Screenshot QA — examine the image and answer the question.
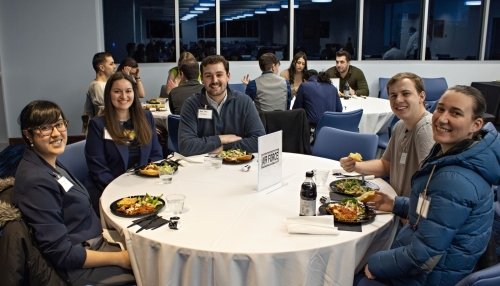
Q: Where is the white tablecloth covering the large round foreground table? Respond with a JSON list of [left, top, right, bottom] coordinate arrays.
[[100, 153, 396, 286]]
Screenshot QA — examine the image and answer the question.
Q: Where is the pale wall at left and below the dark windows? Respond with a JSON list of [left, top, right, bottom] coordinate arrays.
[[0, 0, 500, 144]]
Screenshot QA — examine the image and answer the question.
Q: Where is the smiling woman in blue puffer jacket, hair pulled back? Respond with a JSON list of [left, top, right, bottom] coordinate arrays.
[[358, 86, 500, 286]]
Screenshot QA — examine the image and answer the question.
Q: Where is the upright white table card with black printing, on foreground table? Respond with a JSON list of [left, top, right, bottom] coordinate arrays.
[[257, 130, 283, 191]]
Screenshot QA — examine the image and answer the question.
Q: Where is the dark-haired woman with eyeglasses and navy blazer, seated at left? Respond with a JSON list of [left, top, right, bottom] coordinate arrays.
[[13, 100, 135, 285]]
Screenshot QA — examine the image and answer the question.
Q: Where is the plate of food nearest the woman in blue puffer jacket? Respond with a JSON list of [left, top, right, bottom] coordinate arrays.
[[326, 198, 375, 223]]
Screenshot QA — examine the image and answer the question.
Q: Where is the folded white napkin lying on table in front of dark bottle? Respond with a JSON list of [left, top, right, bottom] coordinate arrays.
[[286, 216, 339, 234]]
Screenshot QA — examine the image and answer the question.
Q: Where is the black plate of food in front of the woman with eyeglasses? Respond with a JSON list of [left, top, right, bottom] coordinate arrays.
[[110, 194, 165, 217]]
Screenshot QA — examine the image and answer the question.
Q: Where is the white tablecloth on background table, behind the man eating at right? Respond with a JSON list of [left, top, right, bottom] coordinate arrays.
[[341, 97, 394, 134]]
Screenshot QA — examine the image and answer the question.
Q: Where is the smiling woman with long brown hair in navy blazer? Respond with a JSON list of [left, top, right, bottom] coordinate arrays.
[[85, 72, 163, 196]]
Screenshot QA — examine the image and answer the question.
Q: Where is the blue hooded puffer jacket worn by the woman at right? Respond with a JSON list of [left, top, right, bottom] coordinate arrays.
[[368, 125, 500, 286]]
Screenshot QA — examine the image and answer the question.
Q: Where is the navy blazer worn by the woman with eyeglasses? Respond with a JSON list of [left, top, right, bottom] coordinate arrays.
[[12, 149, 102, 270]]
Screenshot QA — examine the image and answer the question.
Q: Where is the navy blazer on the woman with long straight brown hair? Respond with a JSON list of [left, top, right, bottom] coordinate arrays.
[[85, 110, 163, 192]]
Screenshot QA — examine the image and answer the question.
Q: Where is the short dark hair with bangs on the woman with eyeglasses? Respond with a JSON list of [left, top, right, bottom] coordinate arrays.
[[19, 100, 66, 146]]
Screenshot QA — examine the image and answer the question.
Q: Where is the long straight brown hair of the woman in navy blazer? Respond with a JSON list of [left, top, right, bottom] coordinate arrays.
[[104, 72, 153, 145]]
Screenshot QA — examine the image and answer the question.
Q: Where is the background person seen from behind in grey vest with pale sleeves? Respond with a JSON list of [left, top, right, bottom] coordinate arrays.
[[241, 53, 292, 112]]
